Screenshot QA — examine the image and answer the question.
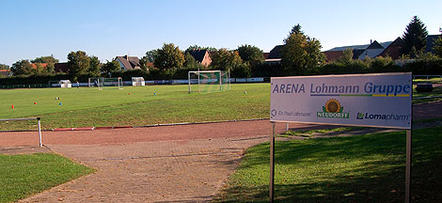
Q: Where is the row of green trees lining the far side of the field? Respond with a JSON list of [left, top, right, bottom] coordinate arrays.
[[0, 16, 442, 81]]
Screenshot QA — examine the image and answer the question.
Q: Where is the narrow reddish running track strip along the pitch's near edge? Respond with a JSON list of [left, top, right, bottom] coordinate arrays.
[[0, 120, 314, 146]]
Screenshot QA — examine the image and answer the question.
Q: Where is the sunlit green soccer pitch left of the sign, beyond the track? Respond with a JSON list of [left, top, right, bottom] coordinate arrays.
[[0, 83, 270, 130]]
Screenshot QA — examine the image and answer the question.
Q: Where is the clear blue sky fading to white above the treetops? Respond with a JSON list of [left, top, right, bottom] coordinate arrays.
[[0, 0, 442, 65]]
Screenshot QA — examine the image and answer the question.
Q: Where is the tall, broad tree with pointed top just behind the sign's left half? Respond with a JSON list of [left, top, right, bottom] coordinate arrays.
[[281, 24, 325, 74]]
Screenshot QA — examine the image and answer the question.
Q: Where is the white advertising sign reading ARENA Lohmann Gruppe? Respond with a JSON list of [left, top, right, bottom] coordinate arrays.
[[270, 73, 413, 129]]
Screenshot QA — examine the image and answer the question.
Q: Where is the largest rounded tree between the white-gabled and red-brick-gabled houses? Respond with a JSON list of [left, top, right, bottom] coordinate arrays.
[[154, 43, 184, 70]]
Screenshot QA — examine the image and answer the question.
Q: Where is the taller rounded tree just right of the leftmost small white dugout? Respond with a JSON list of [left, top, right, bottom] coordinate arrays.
[[68, 51, 91, 82]]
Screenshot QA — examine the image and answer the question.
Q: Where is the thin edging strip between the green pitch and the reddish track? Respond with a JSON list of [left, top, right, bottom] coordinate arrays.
[[0, 118, 269, 133]]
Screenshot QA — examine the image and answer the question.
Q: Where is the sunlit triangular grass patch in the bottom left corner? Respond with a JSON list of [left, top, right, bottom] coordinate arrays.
[[0, 153, 94, 202]]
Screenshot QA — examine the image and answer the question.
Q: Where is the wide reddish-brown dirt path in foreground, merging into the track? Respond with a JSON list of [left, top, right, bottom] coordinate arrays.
[[0, 121, 308, 202]]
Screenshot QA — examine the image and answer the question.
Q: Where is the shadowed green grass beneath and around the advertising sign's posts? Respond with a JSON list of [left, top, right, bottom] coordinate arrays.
[[214, 127, 442, 202]]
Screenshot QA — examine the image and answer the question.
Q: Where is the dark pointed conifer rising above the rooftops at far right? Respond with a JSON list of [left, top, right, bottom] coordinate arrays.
[[402, 16, 428, 58]]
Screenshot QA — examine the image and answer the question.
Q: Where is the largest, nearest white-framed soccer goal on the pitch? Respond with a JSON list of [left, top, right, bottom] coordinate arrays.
[[188, 70, 230, 93]]
